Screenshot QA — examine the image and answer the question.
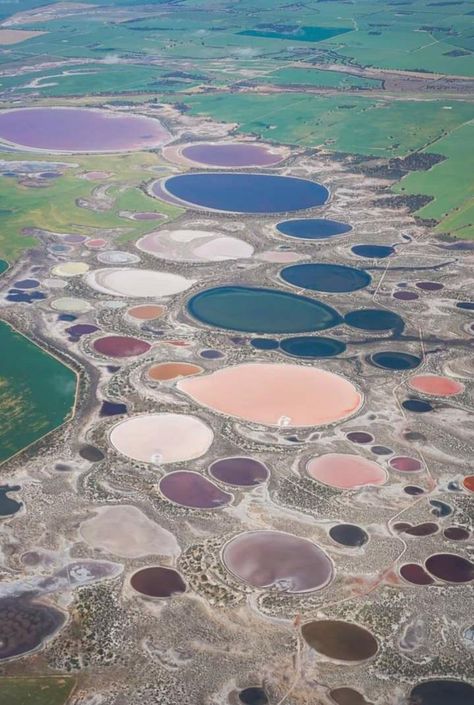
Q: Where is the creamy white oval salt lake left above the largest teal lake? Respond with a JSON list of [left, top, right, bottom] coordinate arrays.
[[86, 267, 195, 298]]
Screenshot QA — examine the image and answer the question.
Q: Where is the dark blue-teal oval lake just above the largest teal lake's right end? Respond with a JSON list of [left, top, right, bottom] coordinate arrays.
[[280, 263, 371, 294]]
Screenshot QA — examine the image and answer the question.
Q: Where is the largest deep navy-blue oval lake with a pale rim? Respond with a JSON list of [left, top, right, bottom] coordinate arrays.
[[161, 172, 329, 213]]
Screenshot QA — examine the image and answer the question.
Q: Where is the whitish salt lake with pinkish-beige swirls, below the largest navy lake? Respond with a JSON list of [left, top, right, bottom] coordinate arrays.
[[136, 229, 253, 262]]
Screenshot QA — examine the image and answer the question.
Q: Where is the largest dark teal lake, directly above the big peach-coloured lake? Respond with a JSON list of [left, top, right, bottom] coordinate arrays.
[[188, 286, 343, 334]]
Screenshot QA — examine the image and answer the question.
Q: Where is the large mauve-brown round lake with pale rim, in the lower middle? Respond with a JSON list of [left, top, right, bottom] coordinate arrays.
[[222, 531, 334, 594]]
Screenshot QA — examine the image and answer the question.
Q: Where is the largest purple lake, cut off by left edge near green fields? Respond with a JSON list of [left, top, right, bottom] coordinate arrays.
[[0, 108, 170, 152]]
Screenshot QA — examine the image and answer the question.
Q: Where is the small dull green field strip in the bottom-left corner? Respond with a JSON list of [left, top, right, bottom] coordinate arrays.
[[0, 676, 75, 705]]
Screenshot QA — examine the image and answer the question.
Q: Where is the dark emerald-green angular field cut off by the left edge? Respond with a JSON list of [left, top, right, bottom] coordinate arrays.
[[0, 321, 76, 463]]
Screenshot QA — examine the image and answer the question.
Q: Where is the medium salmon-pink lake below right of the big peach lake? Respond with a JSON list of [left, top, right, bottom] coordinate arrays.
[[306, 453, 387, 489]]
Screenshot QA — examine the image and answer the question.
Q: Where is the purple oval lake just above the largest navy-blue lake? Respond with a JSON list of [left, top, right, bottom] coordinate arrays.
[[180, 142, 283, 167]]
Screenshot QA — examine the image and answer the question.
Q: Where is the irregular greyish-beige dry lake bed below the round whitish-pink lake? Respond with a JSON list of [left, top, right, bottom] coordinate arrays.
[[80, 505, 181, 558]]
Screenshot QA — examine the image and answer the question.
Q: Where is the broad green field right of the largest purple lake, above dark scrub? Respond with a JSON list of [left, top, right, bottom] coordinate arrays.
[[178, 93, 474, 157]]
